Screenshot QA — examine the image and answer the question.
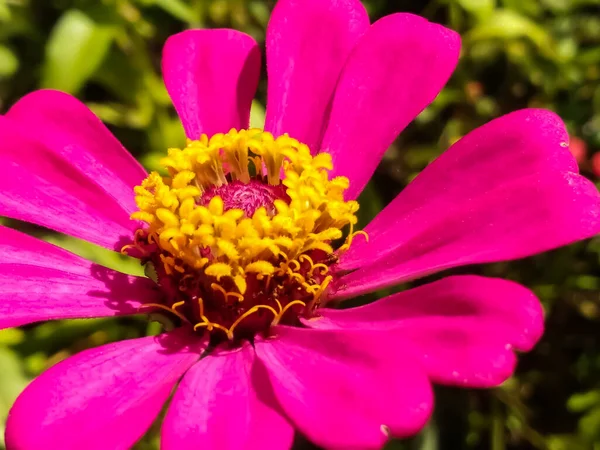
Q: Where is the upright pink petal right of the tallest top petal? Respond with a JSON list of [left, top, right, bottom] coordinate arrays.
[[322, 14, 460, 199]]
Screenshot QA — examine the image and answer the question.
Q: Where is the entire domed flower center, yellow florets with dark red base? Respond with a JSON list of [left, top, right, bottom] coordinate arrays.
[[124, 129, 364, 341]]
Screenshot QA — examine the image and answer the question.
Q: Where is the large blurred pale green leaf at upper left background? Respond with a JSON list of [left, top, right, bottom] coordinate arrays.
[[42, 9, 115, 94]]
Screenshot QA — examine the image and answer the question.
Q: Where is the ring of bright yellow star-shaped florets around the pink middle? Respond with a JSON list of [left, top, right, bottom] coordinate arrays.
[[132, 129, 358, 295]]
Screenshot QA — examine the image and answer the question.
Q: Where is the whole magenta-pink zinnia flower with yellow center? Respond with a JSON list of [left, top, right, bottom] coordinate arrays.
[[0, 0, 600, 450]]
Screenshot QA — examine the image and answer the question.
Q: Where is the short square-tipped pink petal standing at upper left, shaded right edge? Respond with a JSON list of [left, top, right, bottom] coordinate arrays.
[[162, 29, 260, 139]]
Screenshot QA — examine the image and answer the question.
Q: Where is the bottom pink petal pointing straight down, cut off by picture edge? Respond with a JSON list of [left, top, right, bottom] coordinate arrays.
[[161, 344, 294, 450]]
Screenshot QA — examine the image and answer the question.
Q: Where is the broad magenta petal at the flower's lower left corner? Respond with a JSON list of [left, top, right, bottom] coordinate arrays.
[[6, 334, 199, 450]]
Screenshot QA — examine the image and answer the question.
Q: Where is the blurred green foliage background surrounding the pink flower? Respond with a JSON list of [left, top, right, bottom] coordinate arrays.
[[0, 0, 600, 450]]
